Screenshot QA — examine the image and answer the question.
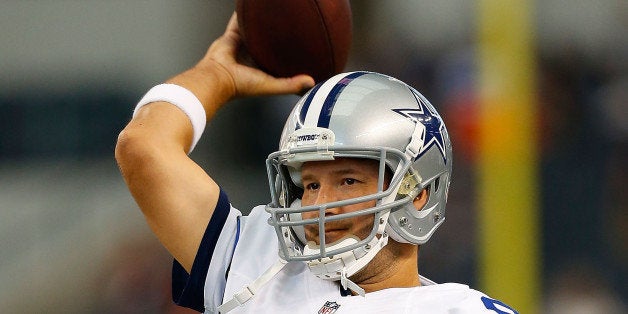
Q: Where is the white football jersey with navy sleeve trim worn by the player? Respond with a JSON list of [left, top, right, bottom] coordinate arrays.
[[173, 192, 516, 314]]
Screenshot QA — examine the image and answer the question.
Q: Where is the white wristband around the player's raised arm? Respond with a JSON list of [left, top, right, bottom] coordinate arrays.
[[133, 84, 207, 154]]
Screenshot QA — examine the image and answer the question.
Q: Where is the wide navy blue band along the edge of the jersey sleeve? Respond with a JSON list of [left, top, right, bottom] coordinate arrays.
[[172, 189, 231, 312]]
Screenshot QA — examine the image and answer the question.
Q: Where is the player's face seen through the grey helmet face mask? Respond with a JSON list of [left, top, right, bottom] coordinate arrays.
[[301, 158, 386, 245]]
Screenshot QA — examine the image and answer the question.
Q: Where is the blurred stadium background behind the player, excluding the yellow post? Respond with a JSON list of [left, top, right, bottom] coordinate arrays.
[[0, 0, 628, 314]]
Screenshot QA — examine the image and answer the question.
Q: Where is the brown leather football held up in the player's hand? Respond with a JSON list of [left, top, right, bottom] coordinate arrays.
[[236, 0, 352, 82]]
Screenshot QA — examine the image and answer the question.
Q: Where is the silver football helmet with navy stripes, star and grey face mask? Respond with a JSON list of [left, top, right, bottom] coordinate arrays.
[[266, 72, 452, 290]]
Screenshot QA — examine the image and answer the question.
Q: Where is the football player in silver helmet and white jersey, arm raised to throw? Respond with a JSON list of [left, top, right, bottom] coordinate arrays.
[[116, 13, 516, 314]]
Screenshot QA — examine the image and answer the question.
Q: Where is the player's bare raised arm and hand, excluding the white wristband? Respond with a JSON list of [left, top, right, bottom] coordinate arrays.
[[115, 14, 314, 272]]
